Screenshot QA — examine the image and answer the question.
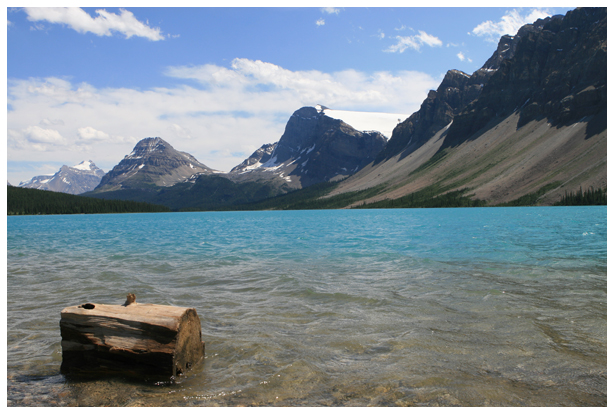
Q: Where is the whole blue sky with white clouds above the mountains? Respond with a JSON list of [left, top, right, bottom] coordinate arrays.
[[6, 1, 584, 185]]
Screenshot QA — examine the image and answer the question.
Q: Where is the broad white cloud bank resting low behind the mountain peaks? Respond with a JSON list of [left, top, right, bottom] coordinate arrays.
[[7, 59, 441, 182]]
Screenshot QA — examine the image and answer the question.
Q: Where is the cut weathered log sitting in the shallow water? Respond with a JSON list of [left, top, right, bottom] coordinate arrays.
[[60, 294, 205, 377]]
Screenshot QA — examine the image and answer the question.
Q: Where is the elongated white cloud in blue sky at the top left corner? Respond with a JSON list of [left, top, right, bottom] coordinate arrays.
[[24, 7, 164, 40]]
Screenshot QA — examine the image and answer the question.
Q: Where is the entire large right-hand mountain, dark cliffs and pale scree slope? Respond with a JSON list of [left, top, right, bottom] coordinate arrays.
[[330, 8, 607, 205]]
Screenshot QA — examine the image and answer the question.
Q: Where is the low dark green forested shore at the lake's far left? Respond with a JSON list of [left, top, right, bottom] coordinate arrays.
[[7, 186, 170, 215]]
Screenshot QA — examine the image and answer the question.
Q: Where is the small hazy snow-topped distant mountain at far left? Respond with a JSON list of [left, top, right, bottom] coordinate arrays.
[[19, 161, 104, 194]]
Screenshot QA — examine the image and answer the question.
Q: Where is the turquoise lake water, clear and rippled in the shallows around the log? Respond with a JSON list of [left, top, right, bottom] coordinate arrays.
[[7, 207, 607, 406]]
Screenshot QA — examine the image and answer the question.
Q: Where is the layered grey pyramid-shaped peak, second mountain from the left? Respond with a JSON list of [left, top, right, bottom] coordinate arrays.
[[96, 138, 213, 191]]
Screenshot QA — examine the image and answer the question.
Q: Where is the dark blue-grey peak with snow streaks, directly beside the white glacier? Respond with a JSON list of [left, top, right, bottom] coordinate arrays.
[[230, 107, 386, 187]]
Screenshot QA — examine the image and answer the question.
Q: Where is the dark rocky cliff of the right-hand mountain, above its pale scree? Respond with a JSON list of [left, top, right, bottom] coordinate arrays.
[[376, 8, 607, 163]]
